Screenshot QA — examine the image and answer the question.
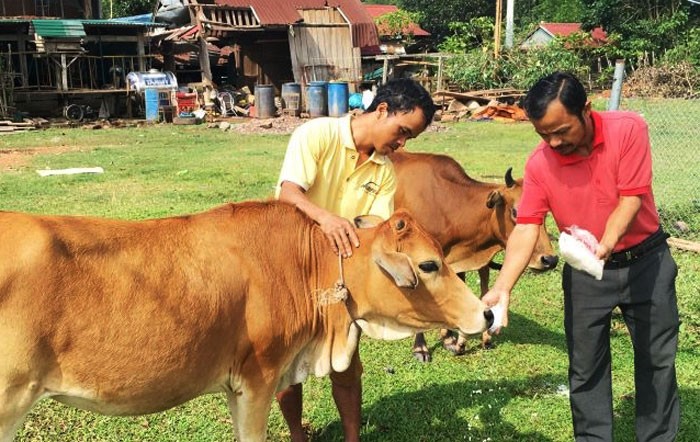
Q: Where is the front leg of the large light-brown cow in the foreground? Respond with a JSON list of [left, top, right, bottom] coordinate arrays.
[[227, 380, 275, 442]]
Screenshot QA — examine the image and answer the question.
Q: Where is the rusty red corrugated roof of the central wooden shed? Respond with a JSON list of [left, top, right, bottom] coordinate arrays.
[[215, 0, 379, 48]]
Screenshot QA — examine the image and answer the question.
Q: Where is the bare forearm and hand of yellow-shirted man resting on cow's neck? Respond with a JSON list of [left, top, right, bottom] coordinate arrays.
[[279, 181, 360, 258]]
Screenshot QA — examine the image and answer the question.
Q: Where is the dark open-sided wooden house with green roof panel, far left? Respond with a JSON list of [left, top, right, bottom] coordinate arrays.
[[0, 0, 162, 116]]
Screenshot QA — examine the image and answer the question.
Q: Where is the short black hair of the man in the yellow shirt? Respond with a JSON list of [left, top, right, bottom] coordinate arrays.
[[367, 78, 435, 127]]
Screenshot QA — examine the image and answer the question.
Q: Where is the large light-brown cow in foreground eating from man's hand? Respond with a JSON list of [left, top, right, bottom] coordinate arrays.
[[0, 202, 493, 442]]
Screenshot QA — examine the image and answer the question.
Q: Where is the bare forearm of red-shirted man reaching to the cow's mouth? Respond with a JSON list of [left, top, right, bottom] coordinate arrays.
[[481, 224, 540, 333]]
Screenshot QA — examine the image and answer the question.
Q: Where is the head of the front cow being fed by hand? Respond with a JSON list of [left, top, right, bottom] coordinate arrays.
[[347, 210, 493, 339]]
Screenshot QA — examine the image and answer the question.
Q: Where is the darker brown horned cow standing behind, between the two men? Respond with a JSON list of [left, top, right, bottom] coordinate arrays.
[[391, 151, 558, 362]]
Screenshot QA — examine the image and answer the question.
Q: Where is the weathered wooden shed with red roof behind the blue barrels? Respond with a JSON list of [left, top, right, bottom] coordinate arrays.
[[155, 0, 379, 89]]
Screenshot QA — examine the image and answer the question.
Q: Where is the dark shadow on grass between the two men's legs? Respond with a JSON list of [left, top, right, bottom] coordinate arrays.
[[311, 375, 566, 442]]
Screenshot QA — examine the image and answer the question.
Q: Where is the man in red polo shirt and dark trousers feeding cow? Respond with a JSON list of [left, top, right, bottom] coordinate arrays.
[[482, 72, 680, 441]]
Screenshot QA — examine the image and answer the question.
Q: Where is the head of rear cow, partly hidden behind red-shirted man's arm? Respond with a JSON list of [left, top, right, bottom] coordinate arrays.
[[486, 167, 559, 271]]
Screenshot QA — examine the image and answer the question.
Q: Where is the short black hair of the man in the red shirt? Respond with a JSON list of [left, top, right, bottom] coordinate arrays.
[[523, 72, 588, 120]]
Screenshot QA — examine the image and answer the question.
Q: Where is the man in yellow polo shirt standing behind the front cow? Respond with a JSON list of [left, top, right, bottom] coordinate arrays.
[[277, 79, 435, 442]]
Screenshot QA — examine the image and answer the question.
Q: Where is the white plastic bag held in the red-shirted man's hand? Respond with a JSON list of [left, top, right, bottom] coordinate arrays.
[[559, 226, 605, 281]]
